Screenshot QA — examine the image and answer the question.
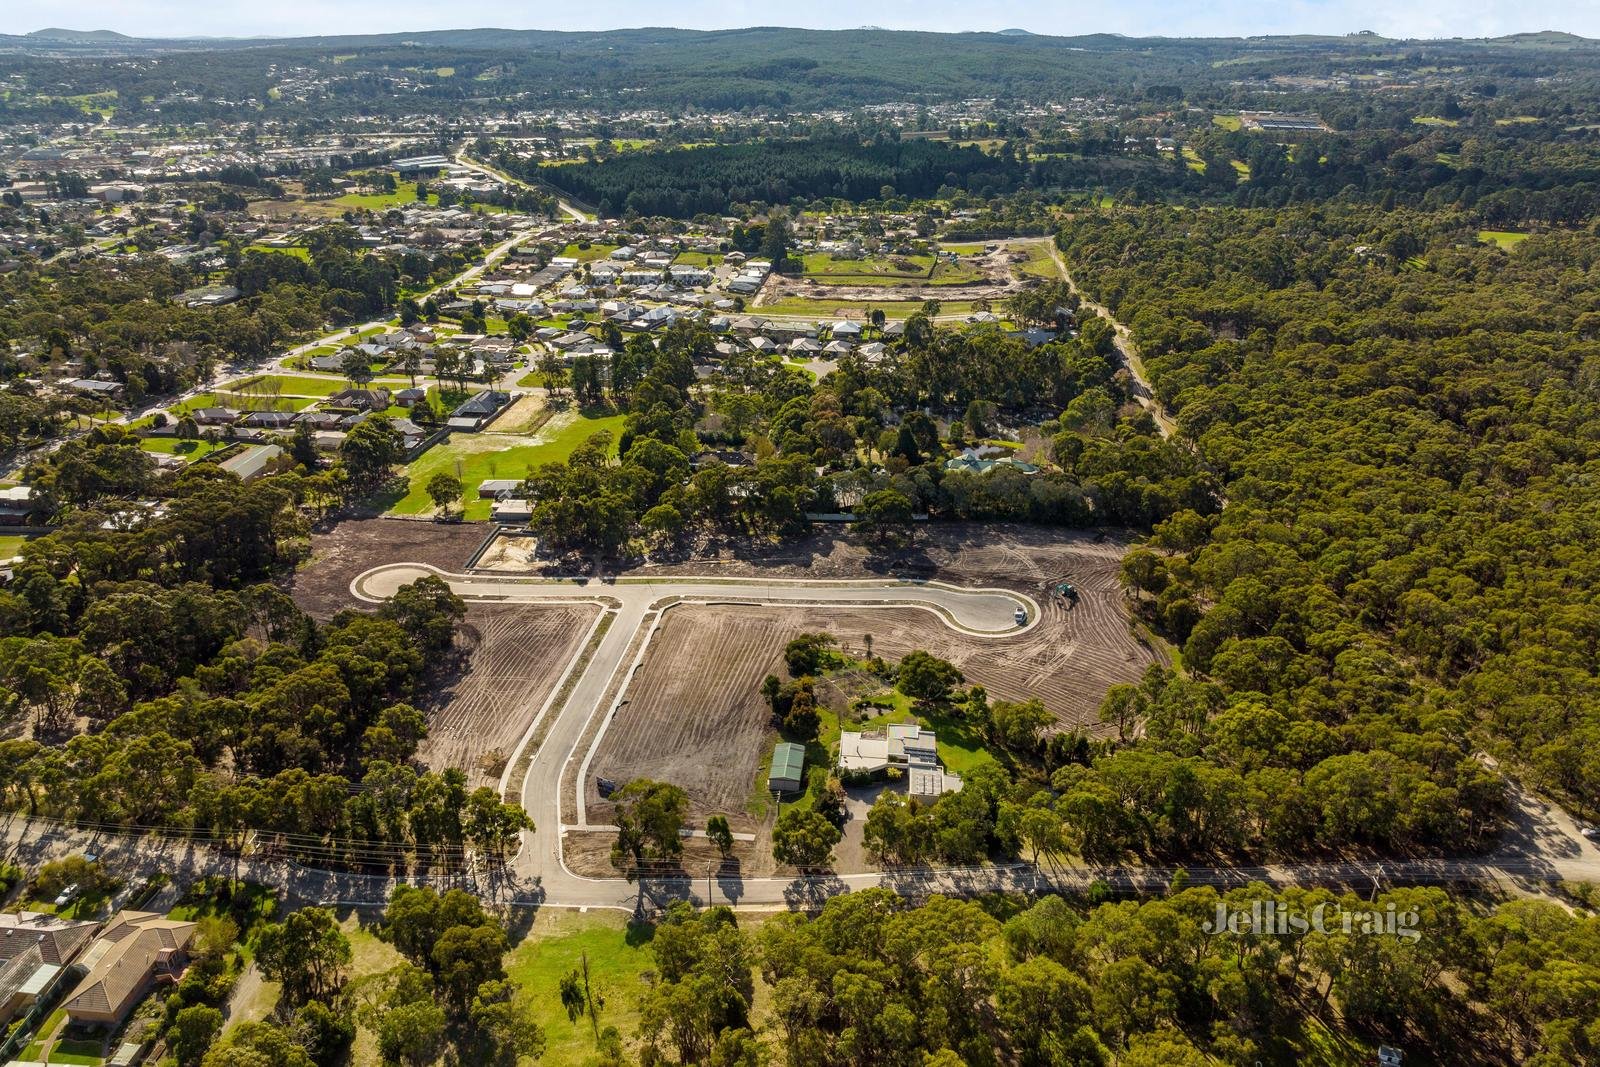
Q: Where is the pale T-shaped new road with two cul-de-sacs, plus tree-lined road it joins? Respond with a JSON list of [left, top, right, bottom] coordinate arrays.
[[344, 563, 1600, 910]]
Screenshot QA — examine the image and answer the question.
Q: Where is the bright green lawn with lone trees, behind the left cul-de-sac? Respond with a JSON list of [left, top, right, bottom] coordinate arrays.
[[389, 414, 626, 518]]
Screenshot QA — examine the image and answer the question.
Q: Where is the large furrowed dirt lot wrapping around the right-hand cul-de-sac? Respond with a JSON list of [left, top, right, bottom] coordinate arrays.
[[586, 528, 1162, 830]]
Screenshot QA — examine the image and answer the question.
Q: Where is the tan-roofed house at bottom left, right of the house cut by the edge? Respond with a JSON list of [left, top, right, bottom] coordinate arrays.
[[62, 912, 197, 1025]]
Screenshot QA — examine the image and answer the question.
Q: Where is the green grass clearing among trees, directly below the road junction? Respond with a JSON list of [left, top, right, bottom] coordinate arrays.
[[506, 910, 656, 1067]]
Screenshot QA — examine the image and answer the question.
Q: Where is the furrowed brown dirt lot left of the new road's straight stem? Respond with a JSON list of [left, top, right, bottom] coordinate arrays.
[[418, 605, 600, 787]]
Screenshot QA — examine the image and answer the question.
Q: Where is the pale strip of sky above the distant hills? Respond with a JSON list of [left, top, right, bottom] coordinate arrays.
[[12, 0, 1600, 37]]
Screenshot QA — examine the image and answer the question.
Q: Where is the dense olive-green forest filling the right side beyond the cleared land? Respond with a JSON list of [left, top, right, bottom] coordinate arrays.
[[1059, 205, 1600, 825]]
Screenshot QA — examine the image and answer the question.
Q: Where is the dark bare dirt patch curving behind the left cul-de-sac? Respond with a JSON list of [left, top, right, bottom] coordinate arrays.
[[288, 518, 488, 619]]
